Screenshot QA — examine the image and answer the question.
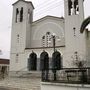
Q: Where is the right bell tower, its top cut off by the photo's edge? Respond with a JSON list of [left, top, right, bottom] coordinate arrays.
[[64, 0, 86, 67]]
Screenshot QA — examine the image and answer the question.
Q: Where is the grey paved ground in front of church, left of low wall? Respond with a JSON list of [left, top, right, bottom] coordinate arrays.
[[0, 77, 40, 90]]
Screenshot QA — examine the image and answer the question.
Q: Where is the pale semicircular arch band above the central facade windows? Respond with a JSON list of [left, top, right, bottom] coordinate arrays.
[[32, 22, 64, 39]]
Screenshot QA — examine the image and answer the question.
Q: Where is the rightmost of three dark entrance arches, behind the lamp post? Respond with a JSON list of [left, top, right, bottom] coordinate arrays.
[[52, 51, 62, 70]]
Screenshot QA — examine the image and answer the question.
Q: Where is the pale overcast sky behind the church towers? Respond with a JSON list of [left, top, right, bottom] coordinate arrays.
[[0, 0, 90, 58]]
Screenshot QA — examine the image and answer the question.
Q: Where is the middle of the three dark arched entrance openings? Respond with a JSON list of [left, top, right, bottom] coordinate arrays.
[[40, 51, 49, 70]]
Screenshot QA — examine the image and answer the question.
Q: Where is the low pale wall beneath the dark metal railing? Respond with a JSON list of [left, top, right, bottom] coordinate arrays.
[[41, 82, 90, 90]]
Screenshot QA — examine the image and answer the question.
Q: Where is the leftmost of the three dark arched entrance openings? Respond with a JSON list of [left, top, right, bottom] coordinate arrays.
[[28, 52, 37, 71]]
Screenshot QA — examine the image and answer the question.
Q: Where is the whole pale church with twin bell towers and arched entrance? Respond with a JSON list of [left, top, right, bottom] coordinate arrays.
[[10, 0, 90, 71]]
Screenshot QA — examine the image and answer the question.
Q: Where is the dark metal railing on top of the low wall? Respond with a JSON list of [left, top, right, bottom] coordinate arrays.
[[42, 67, 90, 84]]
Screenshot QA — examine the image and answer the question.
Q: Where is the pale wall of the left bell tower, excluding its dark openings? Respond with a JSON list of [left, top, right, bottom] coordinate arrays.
[[10, 0, 33, 71]]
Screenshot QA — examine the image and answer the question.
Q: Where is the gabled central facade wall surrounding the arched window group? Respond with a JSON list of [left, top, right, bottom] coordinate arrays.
[[31, 16, 65, 48]]
